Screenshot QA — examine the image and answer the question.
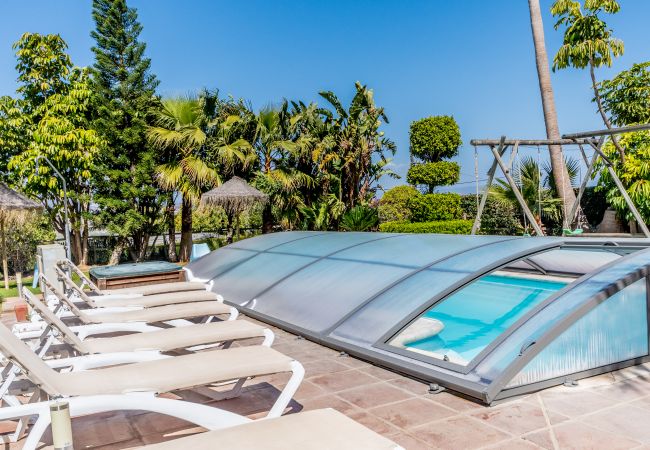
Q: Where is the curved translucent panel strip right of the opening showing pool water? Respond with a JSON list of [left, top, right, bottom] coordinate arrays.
[[475, 249, 650, 382]]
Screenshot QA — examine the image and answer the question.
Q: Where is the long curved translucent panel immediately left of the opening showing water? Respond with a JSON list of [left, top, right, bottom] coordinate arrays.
[[331, 236, 554, 346]]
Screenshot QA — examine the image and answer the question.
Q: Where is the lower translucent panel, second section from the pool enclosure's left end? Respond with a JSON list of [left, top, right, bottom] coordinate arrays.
[[212, 253, 315, 305]]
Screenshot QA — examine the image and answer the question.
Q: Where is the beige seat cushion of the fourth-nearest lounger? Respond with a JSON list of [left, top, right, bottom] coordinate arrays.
[[78, 301, 230, 323]]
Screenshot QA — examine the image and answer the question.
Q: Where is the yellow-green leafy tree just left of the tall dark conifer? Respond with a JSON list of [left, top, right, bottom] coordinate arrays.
[[2, 33, 103, 264]]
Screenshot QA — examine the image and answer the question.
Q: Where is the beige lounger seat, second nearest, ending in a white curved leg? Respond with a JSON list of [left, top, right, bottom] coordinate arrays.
[[51, 345, 293, 396]]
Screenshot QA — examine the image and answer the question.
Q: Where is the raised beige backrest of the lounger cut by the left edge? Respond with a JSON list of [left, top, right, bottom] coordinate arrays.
[[0, 322, 60, 396]]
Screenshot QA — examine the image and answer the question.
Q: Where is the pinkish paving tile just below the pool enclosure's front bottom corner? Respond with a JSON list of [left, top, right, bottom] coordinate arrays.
[[471, 402, 547, 435]]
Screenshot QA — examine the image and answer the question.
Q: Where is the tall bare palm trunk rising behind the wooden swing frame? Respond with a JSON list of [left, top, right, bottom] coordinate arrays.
[[528, 0, 576, 228]]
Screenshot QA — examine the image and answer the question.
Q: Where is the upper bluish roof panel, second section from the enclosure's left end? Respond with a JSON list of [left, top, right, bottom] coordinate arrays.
[[269, 233, 392, 257]]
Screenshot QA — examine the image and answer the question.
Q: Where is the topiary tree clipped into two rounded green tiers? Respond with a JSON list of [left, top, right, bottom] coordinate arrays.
[[407, 116, 463, 193]]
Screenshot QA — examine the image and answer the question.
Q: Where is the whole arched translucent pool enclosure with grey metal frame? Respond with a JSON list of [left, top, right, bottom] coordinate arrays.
[[187, 232, 650, 403]]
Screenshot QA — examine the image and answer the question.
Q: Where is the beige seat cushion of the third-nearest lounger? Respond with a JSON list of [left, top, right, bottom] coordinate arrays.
[[83, 320, 265, 353]]
